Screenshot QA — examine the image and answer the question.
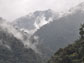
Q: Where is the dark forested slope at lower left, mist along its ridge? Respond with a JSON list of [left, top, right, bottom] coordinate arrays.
[[0, 19, 41, 63]]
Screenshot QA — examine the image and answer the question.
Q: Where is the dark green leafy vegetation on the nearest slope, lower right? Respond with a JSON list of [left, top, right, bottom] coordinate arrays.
[[48, 24, 84, 63]]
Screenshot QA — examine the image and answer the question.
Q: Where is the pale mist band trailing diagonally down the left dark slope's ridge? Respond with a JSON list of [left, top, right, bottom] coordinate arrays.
[[0, 20, 40, 53]]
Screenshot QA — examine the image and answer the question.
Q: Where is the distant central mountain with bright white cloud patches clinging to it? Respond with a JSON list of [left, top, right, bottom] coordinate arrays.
[[13, 9, 58, 33]]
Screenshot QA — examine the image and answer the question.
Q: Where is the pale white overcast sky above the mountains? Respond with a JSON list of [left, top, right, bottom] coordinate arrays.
[[0, 0, 84, 20]]
